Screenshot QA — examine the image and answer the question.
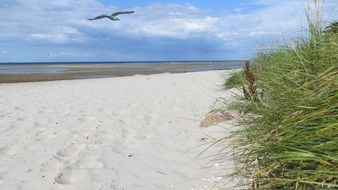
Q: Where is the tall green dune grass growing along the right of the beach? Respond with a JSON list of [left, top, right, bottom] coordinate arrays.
[[225, 2, 338, 189]]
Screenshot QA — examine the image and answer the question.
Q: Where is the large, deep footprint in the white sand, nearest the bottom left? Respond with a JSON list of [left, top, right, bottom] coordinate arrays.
[[54, 168, 87, 184]]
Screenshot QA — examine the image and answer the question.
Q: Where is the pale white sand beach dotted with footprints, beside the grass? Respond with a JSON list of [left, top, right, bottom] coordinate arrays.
[[0, 71, 239, 190]]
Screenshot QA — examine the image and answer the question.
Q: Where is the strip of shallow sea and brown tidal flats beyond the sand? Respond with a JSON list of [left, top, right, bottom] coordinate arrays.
[[0, 61, 243, 83]]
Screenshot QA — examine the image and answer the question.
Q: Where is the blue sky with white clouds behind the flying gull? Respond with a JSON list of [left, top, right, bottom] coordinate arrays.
[[0, 0, 338, 62]]
